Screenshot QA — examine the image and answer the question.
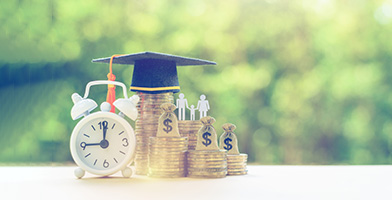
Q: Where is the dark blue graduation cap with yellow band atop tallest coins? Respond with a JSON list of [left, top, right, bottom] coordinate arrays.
[[92, 52, 216, 94]]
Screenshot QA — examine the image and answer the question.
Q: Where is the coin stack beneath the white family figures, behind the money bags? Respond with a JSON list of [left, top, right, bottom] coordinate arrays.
[[178, 120, 203, 150]]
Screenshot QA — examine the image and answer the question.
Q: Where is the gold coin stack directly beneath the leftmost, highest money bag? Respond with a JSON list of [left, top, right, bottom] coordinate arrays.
[[147, 137, 188, 178]]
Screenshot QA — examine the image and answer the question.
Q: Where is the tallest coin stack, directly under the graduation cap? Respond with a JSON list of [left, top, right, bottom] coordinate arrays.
[[135, 92, 174, 175]]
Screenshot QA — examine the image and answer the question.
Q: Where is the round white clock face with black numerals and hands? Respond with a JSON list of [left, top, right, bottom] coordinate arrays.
[[71, 112, 135, 175]]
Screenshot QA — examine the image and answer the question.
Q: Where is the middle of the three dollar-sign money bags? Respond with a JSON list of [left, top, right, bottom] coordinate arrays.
[[195, 116, 219, 151]]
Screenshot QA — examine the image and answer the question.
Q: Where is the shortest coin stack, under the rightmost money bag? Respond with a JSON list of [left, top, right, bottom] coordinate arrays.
[[227, 153, 248, 175]]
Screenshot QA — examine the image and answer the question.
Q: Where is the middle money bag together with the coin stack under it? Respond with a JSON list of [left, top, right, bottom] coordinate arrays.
[[187, 116, 227, 178]]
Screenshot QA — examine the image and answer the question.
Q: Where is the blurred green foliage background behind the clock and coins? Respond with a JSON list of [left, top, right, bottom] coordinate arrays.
[[0, 0, 392, 165]]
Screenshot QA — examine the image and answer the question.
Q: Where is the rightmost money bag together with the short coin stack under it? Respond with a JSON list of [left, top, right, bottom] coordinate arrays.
[[219, 123, 248, 175]]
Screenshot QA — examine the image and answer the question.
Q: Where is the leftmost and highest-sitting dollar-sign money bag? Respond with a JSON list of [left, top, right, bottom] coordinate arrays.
[[157, 103, 180, 137]]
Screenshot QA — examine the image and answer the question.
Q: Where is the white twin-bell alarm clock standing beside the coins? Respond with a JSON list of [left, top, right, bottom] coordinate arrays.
[[70, 81, 139, 178]]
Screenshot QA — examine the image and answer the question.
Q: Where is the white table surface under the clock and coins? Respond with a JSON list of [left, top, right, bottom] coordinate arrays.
[[0, 166, 392, 200]]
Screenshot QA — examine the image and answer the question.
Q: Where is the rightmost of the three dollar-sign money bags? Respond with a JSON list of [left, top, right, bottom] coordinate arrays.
[[219, 123, 240, 155]]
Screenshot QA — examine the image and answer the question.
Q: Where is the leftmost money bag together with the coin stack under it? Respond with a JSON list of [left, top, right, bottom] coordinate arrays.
[[147, 103, 188, 178]]
